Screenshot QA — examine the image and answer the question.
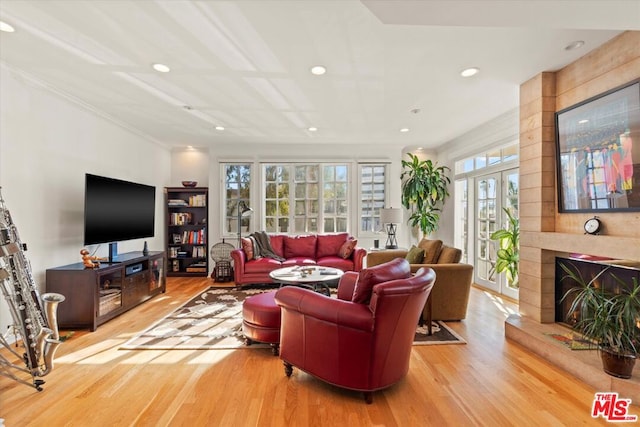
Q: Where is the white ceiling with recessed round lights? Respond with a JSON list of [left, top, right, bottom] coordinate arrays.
[[0, 0, 640, 148]]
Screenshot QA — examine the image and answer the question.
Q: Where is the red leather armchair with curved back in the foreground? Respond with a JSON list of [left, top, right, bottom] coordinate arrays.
[[276, 259, 435, 403]]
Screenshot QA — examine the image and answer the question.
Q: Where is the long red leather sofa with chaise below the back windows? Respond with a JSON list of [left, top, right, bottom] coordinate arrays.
[[231, 233, 367, 287]]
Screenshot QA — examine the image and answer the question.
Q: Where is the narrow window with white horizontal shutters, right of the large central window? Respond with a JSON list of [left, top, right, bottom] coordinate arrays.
[[360, 164, 387, 233]]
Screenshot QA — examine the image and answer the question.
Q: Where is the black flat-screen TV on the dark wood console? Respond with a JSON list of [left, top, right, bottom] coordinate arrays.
[[84, 174, 156, 257]]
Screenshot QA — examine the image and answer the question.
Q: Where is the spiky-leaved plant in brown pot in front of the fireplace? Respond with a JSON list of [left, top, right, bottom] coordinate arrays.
[[560, 263, 640, 378]]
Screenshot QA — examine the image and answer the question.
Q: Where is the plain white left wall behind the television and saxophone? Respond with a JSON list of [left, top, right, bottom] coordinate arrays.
[[0, 65, 171, 333]]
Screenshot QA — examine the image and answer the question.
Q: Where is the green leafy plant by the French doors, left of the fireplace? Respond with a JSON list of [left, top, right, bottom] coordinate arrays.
[[491, 208, 520, 289]]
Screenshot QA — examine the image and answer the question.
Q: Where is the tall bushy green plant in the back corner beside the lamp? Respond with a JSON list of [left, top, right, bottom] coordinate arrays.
[[400, 153, 451, 236]]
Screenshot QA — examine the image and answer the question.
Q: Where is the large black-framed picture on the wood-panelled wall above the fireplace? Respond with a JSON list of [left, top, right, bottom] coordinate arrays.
[[555, 79, 640, 212]]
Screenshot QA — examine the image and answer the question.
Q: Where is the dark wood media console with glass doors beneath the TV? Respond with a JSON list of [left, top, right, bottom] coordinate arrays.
[[46, 252, 167, 332]]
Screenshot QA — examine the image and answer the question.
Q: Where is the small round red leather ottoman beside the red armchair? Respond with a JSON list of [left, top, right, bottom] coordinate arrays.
[[242, 291, 280, 356]]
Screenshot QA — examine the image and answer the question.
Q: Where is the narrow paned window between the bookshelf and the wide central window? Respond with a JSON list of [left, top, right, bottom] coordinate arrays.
[[223, 164, 251, 234]]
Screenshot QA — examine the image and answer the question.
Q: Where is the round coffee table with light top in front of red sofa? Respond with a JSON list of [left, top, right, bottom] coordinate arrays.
[[269, 265, 344, 296]]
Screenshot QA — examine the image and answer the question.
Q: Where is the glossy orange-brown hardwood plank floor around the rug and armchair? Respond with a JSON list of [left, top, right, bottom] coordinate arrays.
[[0, 278, 640, 427]]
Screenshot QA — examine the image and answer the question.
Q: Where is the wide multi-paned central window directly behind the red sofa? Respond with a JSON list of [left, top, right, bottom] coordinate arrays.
[[263, 164, 349, 234]]
